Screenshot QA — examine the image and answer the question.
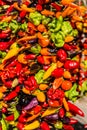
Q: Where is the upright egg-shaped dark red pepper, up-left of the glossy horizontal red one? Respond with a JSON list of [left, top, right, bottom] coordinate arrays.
[[57, 49, 67, 62]]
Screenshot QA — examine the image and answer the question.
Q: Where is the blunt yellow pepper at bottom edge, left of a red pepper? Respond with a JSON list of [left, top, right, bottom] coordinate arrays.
[[24, 120, 40, 130]]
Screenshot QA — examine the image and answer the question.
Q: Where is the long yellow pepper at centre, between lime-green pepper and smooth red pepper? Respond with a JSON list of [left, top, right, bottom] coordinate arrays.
[[43, 63, 57, 80]]
